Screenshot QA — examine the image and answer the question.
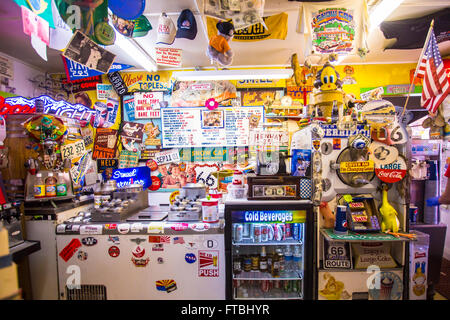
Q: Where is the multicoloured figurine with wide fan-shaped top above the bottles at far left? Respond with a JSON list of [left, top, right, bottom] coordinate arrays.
[[23, 115, 67, 170]]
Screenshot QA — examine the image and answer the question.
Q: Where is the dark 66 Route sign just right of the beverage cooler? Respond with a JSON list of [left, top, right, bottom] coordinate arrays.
[[323, 239, 352, 269]]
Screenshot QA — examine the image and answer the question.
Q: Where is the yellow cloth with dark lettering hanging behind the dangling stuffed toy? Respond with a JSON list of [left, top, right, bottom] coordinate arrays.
[[206, 12, 288, 42]]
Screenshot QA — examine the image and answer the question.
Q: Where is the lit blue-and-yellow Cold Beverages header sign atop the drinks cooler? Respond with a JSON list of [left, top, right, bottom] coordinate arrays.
[[232, 210, 306, 223]]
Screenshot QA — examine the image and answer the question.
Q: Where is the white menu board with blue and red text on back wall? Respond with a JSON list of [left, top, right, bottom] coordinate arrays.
[[161, 107, 264, 148]]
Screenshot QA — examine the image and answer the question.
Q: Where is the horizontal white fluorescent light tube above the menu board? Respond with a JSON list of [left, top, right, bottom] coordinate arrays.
[[172, 68, 294, 81]]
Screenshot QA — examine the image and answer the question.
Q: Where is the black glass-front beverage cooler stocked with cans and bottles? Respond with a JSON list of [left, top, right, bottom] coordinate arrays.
[[225, 200, 314, 300]]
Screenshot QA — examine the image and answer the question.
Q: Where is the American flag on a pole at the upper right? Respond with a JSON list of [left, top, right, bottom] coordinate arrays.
[[417, 29, 450, 113]]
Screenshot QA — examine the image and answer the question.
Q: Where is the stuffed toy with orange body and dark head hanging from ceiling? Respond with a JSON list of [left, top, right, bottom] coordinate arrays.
[[206, 21, 234, 66]]
